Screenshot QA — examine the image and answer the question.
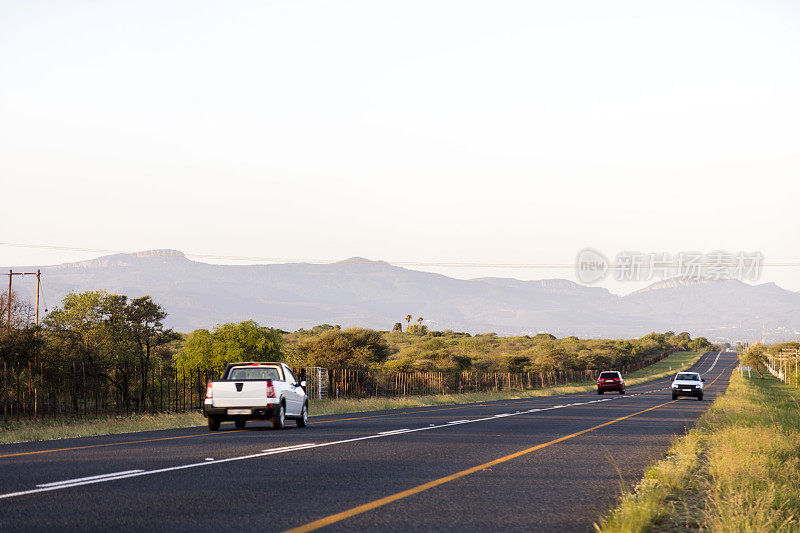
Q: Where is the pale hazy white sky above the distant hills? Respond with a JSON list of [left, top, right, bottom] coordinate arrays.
[[0, 0, 800, 292]]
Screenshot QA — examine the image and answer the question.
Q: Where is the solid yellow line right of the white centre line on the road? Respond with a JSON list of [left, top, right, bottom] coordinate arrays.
[[285, 358, 730, 533]]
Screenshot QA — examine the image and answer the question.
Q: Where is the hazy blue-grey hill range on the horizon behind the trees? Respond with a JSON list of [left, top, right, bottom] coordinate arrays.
[[6, 250, 800, 340]]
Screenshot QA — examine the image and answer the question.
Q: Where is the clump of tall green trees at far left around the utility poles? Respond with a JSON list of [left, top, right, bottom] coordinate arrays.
[[0, 291, 182, 410]]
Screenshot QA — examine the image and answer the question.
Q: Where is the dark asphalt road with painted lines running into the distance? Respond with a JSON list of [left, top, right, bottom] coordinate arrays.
[[0, 352, 736, 531]]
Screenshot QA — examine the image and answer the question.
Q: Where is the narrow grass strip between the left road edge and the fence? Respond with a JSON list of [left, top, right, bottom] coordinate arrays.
[[0, 352, 701, 444]]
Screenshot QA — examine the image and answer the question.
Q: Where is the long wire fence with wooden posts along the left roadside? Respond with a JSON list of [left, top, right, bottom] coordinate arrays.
[[0, 352, 670, 421]]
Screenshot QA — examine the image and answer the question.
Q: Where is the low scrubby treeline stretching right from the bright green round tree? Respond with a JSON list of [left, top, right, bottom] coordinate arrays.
[[283, 324, 712, 372]]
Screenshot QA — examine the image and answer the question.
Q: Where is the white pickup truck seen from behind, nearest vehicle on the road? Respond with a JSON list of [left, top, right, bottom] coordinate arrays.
[[203, 362, 308, 431]]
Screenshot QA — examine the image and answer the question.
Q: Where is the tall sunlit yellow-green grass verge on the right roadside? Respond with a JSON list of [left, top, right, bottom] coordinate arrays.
[[596, 373, 800, 533]]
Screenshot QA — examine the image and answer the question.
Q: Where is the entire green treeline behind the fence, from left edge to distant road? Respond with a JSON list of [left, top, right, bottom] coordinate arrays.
[[0, 291, 711, 382]]
